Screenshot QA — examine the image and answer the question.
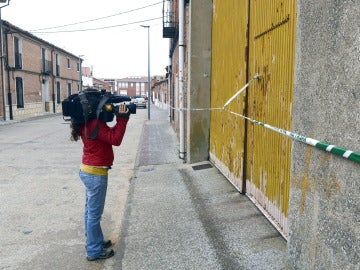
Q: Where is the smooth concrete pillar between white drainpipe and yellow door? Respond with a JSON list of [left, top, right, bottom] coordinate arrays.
[[186, 0, 212, 163]]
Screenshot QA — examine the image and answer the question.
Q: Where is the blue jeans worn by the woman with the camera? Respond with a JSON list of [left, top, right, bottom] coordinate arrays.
[[79, 170, 108, 257]]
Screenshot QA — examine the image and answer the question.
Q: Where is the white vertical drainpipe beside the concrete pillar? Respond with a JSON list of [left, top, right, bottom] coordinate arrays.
[[179, 0, 185, 159]]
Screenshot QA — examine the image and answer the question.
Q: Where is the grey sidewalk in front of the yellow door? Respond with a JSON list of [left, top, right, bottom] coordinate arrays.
[[113, 106, 286, 270]]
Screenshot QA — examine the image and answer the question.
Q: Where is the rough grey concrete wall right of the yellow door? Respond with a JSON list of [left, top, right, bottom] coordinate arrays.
[[288, 0, 360, 269]]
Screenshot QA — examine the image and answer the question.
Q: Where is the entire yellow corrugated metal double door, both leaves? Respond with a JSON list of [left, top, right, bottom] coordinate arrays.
[[210, 0, 296, 235]]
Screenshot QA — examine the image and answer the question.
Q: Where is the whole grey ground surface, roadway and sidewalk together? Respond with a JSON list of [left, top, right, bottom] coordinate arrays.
[[0, 106, 287, 270]]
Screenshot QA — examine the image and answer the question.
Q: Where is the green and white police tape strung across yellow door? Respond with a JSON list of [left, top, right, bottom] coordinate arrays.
[[168, 74, 360, 163]]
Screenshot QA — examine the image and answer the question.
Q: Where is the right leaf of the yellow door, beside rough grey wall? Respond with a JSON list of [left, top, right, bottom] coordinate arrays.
[[246, 0, 296, 235]]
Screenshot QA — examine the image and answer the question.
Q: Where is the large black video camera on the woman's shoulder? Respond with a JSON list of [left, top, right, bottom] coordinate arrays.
[[61, 88, 136, 124]]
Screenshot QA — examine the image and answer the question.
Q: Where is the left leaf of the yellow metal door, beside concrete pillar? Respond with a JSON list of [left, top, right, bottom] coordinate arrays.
[[210, 0, 248, 190]]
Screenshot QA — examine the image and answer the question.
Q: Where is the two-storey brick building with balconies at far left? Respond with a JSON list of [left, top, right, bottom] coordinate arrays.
[[0, 21, 82, 120]]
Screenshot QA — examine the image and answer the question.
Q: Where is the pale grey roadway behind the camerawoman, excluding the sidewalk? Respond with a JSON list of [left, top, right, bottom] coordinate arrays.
[[0, 109, 147, 269]]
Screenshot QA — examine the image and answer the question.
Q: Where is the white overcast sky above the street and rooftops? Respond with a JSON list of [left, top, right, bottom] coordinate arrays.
[[1, 0, 169, 78]]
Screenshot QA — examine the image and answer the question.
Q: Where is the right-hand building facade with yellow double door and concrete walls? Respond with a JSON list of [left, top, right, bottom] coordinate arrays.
[[163, 0, 360, 269]]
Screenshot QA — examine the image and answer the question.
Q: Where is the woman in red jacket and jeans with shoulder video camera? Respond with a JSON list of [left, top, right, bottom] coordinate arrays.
[[62, 89, 136, 261]]
